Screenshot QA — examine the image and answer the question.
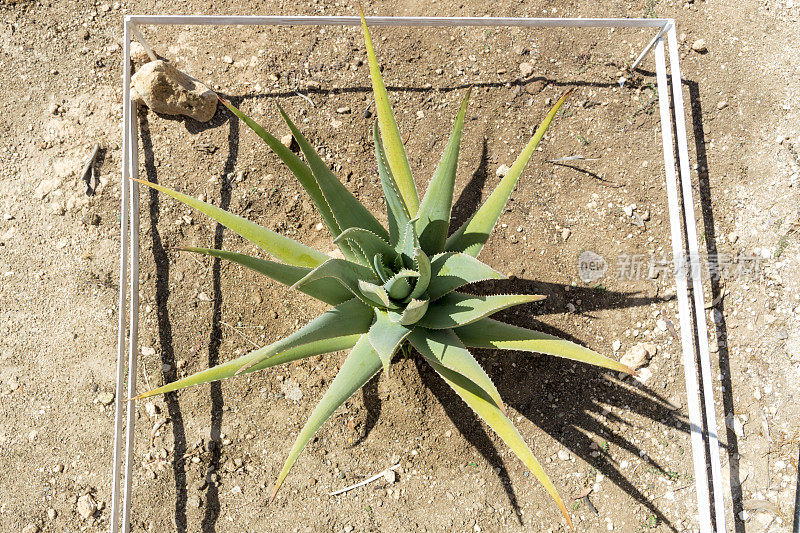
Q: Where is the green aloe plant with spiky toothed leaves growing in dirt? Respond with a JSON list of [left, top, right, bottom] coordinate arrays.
[[137, 15, 632, 525]]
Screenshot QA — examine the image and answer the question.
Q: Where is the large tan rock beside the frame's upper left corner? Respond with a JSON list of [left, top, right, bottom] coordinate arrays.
[[131, 60, 217, 122]]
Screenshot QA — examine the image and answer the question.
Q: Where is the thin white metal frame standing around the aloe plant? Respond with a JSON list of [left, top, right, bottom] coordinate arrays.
[[110, 15, 725, 533]]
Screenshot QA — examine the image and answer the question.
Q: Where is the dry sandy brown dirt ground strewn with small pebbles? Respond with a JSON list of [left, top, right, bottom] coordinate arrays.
[[0, 0, 800, 533]]
